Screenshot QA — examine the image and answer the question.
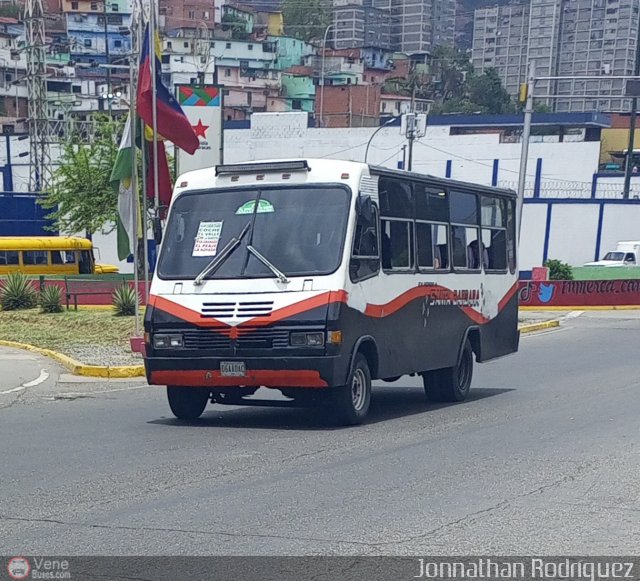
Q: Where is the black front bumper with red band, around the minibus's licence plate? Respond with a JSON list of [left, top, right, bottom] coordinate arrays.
[[145, 356, 348, 389]]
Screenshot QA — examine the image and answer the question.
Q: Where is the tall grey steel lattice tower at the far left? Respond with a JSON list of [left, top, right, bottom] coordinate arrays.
[[24, 0, 51, 192]]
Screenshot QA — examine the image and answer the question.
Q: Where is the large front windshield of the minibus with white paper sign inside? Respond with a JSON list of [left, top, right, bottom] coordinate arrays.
[[158, 186, 350, 279]]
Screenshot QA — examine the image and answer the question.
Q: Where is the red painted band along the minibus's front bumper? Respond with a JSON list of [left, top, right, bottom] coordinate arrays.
[[150, 369, 328, 388]]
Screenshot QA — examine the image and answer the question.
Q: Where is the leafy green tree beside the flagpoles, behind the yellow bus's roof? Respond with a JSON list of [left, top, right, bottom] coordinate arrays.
[[40, 116, 123, 235]]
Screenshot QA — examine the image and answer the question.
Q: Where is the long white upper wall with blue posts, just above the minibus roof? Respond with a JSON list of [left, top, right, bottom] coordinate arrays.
[[224, 115, 604, 198]]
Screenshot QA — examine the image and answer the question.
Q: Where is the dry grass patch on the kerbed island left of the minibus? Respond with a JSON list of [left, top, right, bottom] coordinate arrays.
[[0, 309, 142, 354]]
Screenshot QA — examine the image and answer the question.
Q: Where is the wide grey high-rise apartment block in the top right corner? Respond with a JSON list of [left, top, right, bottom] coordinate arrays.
[[473, 0, 640, 111]]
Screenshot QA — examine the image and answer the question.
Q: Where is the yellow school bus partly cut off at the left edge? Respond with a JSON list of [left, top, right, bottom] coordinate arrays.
[[0, 236, 118, 274]]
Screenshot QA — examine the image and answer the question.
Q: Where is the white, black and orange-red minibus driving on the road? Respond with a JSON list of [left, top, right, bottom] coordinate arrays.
[[145, 159, 519, 424]]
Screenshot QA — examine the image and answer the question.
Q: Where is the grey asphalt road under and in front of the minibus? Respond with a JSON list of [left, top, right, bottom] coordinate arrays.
[[0, 313, 640, 555]]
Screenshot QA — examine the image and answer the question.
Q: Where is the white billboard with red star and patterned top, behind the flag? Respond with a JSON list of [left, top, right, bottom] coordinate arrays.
[[176, 85, 222, 175]]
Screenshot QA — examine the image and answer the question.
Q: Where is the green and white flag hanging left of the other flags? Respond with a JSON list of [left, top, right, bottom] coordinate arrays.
[[110, 117, 136, 260]]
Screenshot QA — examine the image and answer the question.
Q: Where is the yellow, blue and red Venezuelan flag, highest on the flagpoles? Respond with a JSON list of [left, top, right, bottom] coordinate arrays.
[[136, 26, 200, 155]]
